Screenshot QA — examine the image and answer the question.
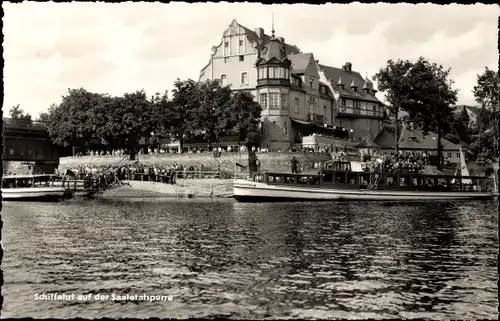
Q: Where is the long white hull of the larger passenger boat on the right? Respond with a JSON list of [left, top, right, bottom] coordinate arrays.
[[233, 180, 498, 201]]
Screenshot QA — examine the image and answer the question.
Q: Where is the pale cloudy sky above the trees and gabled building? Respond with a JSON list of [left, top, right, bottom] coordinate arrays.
[[2, 2, 500, 115]]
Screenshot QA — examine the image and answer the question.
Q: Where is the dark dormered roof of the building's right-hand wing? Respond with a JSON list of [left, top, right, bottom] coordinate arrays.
[[319, 64, 382, 103]]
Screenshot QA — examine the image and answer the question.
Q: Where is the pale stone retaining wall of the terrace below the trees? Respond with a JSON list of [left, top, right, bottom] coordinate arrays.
[[59, 153, 331, 172]]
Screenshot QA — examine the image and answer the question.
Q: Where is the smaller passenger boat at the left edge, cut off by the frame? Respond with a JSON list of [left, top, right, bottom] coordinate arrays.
[[2, 174, 72, 201]]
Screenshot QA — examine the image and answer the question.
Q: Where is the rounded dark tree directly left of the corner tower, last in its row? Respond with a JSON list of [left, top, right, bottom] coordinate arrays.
[[227, 91, 262, 148]]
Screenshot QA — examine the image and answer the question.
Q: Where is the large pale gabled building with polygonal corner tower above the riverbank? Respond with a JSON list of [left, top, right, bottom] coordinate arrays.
[[199, 20, 385, 150]]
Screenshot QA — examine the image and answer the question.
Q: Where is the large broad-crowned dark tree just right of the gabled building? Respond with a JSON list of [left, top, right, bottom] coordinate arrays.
[[374, 57, 458, 169]]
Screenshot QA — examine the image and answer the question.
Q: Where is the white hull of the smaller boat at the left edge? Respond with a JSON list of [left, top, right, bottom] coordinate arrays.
[[2, 186, 67, 201]]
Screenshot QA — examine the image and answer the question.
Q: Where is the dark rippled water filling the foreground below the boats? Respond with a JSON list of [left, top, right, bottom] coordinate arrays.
[[1, 197, 498, 319]]
